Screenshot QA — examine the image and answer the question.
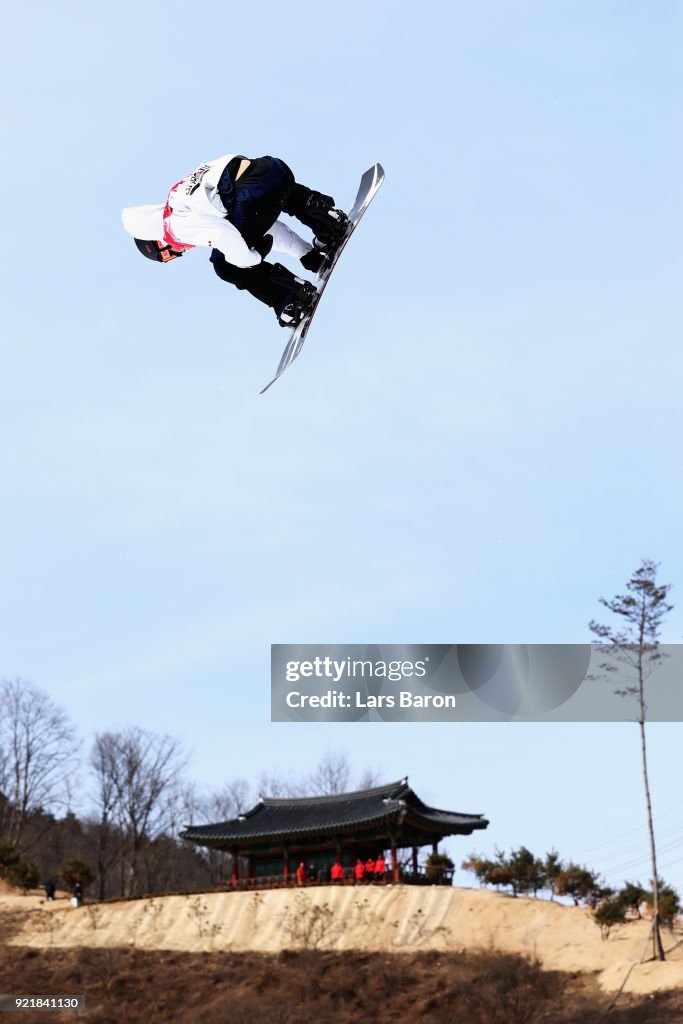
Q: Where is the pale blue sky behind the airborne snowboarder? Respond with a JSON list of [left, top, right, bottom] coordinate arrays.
[[0, 0, 683, 888]]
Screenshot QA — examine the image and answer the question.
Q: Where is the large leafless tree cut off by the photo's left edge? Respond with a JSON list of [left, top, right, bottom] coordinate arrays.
[[0, 679, 79, 848]]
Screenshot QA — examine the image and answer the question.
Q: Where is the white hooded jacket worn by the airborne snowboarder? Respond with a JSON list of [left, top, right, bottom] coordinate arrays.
[[122, 154, 311, 267]]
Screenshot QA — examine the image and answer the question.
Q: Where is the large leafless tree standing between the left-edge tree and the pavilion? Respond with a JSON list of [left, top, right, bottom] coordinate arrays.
[[91, 726, 187, 895]]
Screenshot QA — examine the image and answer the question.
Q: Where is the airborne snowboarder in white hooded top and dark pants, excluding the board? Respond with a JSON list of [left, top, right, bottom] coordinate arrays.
[[122, 155, 348, 327]]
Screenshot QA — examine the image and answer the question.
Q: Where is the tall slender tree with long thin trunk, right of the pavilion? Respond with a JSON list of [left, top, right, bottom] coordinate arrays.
[[589, 559, 673, 959]]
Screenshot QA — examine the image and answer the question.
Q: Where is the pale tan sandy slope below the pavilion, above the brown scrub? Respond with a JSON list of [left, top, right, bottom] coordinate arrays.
[[0, 886, 683, 993]]
